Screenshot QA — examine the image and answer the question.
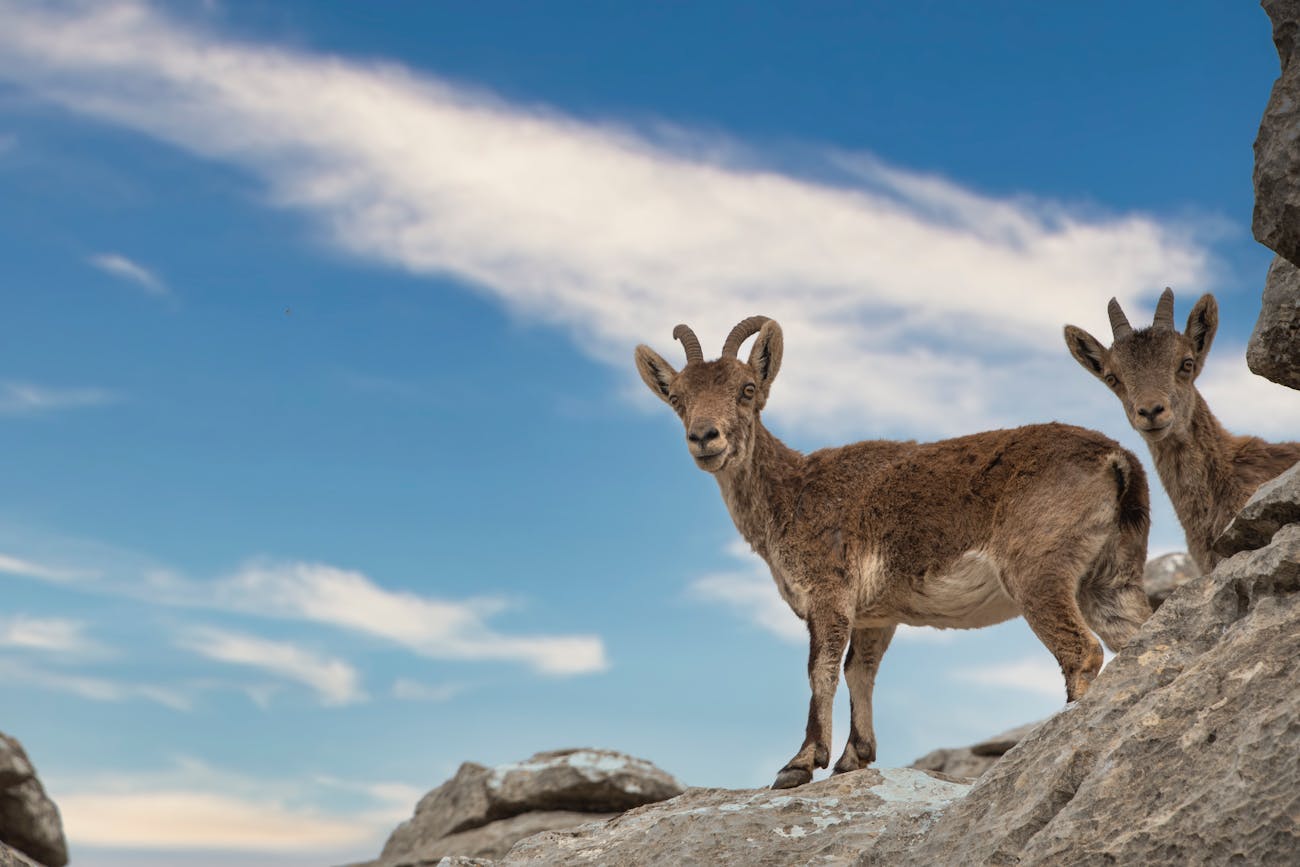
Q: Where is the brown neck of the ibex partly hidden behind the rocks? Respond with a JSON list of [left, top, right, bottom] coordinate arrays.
[[1148, 390, 1243, 571]]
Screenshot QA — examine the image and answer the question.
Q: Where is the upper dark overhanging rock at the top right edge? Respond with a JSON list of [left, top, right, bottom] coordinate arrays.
[[1252, 0, 1300, 265]]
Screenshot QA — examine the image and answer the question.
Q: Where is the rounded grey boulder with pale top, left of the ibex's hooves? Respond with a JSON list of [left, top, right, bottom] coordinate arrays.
[[373, 750, 683, 867]]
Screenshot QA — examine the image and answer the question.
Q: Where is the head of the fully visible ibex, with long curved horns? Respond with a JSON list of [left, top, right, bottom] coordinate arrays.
[[636, 316, 783, 473]]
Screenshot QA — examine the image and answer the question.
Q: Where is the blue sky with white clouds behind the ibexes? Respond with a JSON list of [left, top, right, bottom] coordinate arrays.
[[0, 0, 1284, 866]]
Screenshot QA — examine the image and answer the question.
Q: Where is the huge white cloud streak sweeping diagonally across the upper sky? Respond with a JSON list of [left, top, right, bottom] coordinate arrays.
[[0, 0, 1213, 434]]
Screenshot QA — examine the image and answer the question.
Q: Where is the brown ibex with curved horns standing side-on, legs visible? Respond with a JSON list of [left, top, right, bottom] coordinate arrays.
[[636, 316, 1151, 789]]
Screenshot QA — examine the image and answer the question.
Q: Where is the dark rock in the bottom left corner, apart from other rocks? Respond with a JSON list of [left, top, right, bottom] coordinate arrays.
[[0, 734, 68, 867]]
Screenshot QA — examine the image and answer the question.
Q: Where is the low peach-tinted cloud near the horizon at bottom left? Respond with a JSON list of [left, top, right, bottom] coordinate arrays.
[[51, 759, 408, 863]]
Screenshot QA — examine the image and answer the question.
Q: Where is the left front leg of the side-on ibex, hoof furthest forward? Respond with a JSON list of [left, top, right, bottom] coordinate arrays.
[[772, 607, 850, 789]]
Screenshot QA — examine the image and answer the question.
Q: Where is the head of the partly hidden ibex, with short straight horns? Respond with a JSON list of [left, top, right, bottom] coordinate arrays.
[[1065, 289, 1218, 442]]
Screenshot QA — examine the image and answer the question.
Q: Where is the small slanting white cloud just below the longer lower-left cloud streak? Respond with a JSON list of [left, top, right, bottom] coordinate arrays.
[[177, 627, 367, 706]]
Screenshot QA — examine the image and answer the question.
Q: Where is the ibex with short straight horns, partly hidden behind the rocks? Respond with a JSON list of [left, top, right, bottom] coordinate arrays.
[[1065, 289, 1300, 572]]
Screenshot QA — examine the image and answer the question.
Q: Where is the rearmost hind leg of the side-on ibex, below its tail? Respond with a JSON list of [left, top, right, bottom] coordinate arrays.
[[1079, 522, 1151, 653]]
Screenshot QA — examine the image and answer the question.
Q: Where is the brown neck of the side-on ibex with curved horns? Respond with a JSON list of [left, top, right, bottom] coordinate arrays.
[[716, 420, 803, 558]]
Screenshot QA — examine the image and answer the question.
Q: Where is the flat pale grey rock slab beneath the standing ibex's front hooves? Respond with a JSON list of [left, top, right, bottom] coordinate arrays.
[[498, 768, 970, 867]]
